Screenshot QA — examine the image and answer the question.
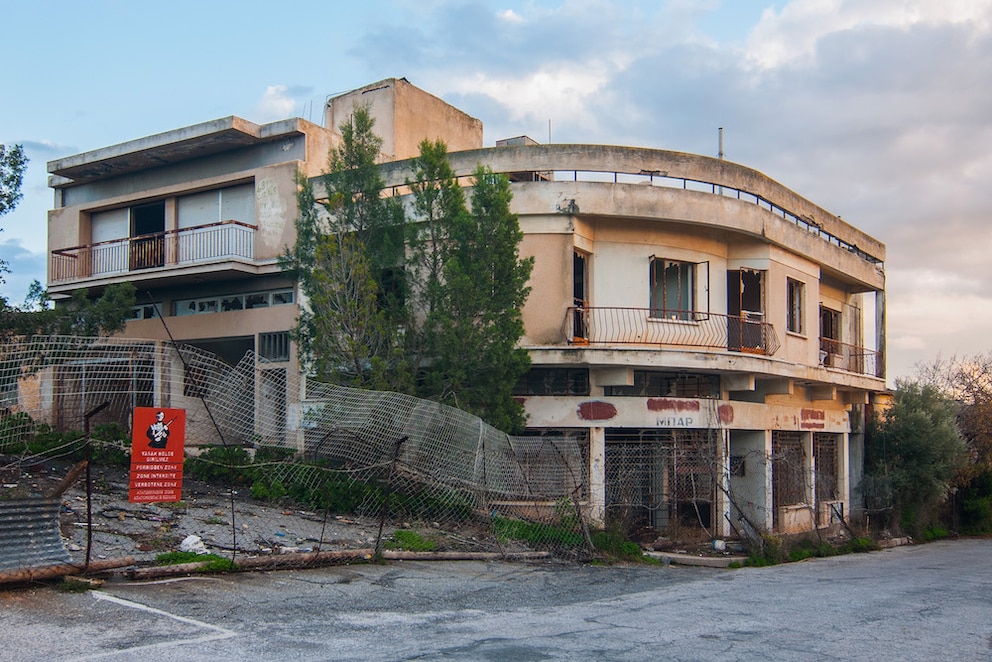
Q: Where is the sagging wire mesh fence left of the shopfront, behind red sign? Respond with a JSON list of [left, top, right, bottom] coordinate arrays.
[[0, 337, 592, 572]]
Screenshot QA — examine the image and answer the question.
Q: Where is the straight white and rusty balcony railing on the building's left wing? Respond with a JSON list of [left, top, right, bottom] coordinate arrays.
[[51, 221, 256, 283]]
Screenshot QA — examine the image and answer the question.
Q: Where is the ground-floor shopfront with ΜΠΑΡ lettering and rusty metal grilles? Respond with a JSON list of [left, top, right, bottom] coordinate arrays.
[[527, 398, 862, 539]]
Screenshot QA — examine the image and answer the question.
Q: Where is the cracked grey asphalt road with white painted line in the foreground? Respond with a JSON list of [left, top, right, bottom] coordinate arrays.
[[0, 539, 992, 662]]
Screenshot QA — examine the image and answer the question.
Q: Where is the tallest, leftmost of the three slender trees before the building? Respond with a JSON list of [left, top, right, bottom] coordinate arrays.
[[282, 107, 412, 391]]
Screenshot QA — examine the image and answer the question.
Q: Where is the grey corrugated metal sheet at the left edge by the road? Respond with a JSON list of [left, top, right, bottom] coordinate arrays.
[[0, 497, 71, 571]]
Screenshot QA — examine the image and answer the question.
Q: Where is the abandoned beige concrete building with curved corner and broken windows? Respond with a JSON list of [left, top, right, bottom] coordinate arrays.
[[42, 79, 885, 535]]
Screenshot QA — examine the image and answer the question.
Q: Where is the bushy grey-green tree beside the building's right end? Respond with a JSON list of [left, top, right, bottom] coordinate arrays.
[[862, 381, 967, 534]]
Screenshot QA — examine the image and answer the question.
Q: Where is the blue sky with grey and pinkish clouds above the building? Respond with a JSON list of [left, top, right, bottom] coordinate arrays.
[[0, 0, 992, 383]]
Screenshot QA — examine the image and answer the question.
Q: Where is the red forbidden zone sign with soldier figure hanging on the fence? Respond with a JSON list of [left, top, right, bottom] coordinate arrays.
[[128, 407, 186, 503]]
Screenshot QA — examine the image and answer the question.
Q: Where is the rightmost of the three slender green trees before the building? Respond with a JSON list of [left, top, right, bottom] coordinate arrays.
[[432, 166, 534, 432]]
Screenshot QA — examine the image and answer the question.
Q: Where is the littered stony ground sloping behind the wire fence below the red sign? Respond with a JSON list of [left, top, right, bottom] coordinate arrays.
[[0, 458, 536, 563]]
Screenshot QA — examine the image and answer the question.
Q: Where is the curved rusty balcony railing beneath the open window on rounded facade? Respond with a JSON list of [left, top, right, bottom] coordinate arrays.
[[562, 307, 781, 356]]
